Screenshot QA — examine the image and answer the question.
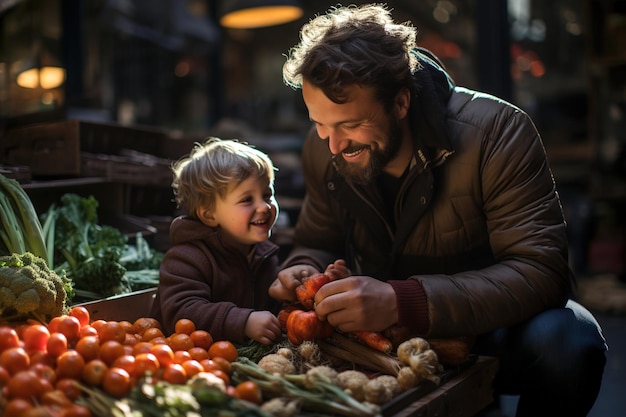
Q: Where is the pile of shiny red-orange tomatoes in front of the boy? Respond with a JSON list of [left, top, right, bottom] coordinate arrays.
[[0, 306, 261, 417]]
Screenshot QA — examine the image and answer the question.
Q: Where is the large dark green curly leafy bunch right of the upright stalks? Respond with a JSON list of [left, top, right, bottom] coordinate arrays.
[[43, 193, 131, 297]]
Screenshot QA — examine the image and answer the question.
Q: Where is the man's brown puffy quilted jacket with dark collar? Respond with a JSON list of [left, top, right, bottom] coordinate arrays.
[[285, 53, 573, 337]]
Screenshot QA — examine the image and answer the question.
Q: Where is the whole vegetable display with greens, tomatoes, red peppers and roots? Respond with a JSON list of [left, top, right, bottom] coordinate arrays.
[[0, 174, 471, 417]]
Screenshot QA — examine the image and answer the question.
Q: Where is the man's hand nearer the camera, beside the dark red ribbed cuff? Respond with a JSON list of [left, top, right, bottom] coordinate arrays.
[[315, 276, 398, 332]]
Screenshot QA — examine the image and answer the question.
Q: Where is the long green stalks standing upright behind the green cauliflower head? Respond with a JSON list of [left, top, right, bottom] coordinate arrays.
[[0, 174, 48, 259]]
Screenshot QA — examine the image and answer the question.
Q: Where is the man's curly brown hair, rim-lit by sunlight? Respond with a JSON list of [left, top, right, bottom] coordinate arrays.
[[283, 4, 419, 104]]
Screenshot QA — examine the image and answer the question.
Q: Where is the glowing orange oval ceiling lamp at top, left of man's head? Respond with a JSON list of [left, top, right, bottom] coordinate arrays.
[[220, 0, 303, 29]]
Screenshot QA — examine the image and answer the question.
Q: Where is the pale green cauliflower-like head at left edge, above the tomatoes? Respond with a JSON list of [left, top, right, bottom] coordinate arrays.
[[0, 252, 73, 323]]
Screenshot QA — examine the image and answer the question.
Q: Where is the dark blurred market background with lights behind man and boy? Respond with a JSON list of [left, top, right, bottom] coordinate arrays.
[[0, 0, 626, 417]]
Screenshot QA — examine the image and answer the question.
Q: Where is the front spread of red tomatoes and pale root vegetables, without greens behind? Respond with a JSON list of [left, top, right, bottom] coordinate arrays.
[[0, 306, 458, 417]]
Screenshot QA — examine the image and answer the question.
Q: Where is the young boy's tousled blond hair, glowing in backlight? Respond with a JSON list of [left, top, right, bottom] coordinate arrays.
[[172, 137, 275, 218]]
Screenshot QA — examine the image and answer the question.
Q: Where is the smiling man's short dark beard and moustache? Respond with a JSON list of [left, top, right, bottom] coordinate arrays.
[[333, 118, 402, 185]]
